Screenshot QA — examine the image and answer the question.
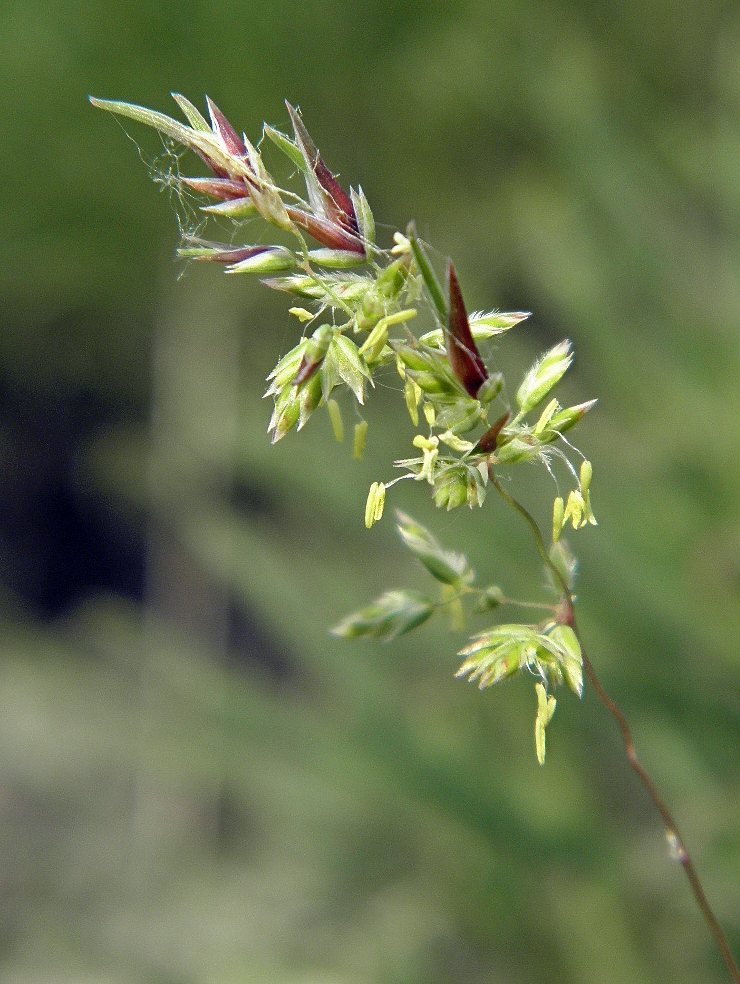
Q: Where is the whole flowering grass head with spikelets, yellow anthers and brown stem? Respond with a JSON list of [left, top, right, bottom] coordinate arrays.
[[91, 93, 740, 981]]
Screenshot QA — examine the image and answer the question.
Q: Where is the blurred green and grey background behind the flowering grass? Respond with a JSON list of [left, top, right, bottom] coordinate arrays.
[[0, 0, 740, 984]]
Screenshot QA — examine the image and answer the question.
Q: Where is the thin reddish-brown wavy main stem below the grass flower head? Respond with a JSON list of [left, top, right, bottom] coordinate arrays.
[[489, 470, 740, 984]]
